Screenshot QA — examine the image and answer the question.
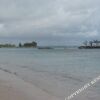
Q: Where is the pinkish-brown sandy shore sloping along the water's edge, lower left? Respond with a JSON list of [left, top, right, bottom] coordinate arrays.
[[0, 70, 60, 100]]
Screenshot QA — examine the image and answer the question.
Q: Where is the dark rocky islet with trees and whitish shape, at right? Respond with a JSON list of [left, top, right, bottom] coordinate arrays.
[[78, 40, 100, 49]]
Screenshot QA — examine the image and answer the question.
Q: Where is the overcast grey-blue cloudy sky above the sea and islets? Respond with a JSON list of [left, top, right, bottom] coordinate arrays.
[[0, 0, 100, 45]]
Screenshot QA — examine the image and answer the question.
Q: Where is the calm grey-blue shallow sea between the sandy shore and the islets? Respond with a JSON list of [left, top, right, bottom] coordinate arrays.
[[0, 48, 100, 100]]
